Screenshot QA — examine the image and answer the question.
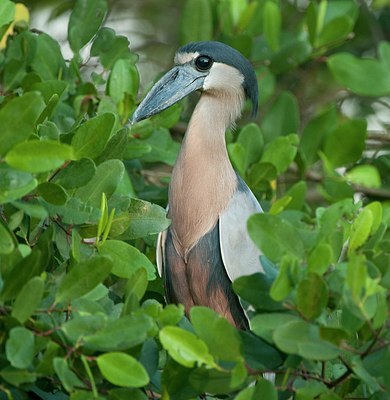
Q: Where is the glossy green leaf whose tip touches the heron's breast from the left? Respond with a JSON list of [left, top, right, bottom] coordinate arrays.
[[116, 199, 170, 239]]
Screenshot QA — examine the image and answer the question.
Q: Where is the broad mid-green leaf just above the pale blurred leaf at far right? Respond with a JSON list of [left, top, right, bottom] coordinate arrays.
[[324, 120, 367, 167]]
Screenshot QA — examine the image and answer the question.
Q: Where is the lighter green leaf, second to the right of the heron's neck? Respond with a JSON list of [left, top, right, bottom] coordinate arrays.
[[261, 134, 298, 174]]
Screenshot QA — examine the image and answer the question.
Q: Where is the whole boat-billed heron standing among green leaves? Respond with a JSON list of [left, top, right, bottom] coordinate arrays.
[[132, 42, 263, 329]]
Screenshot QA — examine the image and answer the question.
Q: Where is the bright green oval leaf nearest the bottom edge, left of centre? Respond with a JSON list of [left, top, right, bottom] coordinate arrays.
[[96, 352, 149, 387]]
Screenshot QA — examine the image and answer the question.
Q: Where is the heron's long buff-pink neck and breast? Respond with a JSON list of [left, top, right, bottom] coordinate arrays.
[[169, 93, 242, 252]]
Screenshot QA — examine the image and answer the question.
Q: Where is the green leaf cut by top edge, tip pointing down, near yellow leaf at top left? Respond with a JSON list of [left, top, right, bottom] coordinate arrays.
[[68, 0, 107, 53]]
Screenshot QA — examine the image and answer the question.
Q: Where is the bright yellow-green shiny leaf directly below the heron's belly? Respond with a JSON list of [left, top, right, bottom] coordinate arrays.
[[159, 326, 216, 368]]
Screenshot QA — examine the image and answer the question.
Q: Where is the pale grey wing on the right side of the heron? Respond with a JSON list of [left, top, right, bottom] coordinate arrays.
[[219, 177, 264, 281]]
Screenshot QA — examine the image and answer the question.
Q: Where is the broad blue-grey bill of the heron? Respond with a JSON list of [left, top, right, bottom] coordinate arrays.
[[131, 64, 207, 124]]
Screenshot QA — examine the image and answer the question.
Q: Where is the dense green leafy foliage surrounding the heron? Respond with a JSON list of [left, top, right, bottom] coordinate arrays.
[[0, 0, 390, 400]]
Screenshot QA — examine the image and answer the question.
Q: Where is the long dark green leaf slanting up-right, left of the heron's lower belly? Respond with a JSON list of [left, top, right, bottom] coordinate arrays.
[[56, 256, 113, 303]]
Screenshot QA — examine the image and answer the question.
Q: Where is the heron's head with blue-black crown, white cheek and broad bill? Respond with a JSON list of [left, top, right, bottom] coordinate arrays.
[[131, 42, 258, 123]]
